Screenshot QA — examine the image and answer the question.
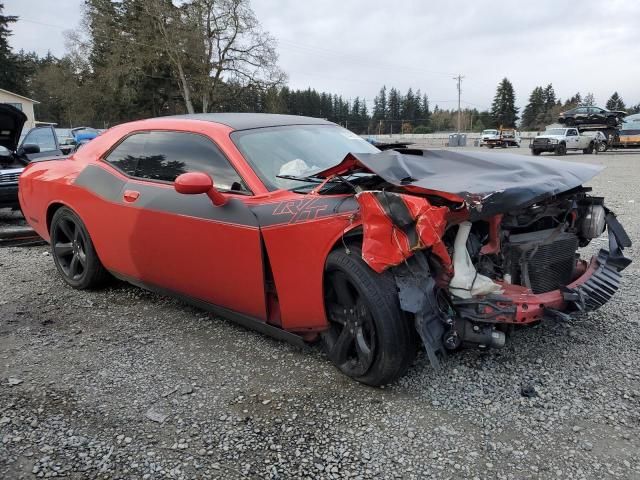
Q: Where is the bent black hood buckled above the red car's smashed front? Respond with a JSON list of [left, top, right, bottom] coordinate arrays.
[[318, 149, 604, 219]]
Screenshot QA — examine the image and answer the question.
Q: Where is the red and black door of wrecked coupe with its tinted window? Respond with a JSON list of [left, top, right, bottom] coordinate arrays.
[[100, 131, 266, 320]]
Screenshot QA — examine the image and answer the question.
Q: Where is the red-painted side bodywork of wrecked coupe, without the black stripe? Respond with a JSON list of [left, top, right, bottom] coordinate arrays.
[[20, 119, 359, 332]]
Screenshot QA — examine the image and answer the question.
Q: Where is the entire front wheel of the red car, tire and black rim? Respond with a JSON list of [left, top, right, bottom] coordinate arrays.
[[322, 248, 418, 386]]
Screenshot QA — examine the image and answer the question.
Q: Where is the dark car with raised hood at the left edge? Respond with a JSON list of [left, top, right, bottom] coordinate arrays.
[[0, 103, 62, 208]]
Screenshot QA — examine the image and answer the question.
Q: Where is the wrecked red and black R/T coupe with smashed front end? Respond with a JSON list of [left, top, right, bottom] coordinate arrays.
[[19, 113, 630, 385]]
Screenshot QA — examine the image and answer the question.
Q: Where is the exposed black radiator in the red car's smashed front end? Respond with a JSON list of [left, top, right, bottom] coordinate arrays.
[[508, 229, 578, 293]]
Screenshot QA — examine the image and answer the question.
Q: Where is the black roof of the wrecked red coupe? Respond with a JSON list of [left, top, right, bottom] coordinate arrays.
[[158, 113, 335, 130]]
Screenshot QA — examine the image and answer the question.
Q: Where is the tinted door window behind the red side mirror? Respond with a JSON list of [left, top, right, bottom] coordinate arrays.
[[133, 131, 248, 191]]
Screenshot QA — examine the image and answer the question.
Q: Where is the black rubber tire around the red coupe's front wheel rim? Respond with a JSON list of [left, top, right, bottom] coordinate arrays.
[[323, 248, 418, 386]]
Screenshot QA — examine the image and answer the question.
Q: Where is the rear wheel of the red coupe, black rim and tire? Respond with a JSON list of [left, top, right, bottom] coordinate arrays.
[[49, 207, 109, 290]]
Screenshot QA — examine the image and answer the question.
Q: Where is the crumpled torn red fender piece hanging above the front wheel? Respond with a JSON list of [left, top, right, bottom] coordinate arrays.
[[356, 191, 452, 273]]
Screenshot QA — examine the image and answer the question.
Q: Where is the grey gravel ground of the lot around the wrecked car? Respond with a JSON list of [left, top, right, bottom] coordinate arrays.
[[0, 150, 640, 479]]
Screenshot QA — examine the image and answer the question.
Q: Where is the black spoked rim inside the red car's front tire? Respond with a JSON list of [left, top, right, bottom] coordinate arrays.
[[324, 270, 376, 377]]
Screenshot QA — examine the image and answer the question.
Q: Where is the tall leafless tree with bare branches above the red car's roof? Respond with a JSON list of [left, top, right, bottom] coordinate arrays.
[[146, 0, 286, 113]]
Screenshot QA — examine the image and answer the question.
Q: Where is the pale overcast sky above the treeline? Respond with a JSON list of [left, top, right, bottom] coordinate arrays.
[[4, 0, 640, 109]]
